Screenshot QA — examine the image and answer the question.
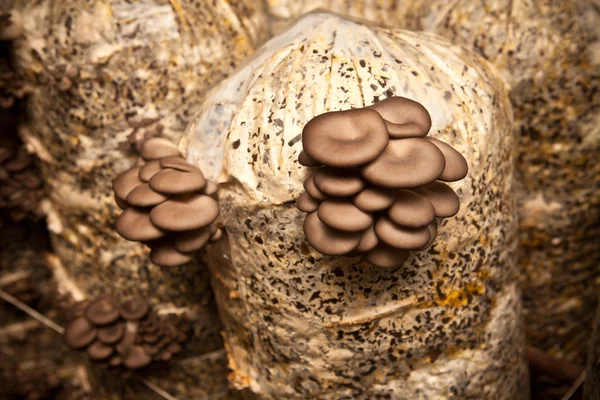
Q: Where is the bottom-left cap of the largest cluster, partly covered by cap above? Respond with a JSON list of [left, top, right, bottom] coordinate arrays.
[[304, 212, 361, 256]]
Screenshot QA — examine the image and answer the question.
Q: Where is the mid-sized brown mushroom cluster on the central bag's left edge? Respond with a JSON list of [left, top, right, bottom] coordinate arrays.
[[113, 138, 222, 266]]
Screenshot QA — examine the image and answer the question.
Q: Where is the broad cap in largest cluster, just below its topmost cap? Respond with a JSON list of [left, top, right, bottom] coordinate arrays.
[[362, 138, 446, 188]]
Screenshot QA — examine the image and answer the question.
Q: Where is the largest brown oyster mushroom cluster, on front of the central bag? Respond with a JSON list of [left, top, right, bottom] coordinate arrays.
[[297, 97, 468, 267]]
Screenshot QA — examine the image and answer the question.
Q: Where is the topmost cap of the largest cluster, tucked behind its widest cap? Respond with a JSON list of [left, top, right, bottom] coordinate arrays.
[[369, 96, 431, 138]]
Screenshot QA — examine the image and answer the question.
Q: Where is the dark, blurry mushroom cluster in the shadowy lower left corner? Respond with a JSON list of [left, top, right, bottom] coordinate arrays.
[[64, 295, 190, 369]]
